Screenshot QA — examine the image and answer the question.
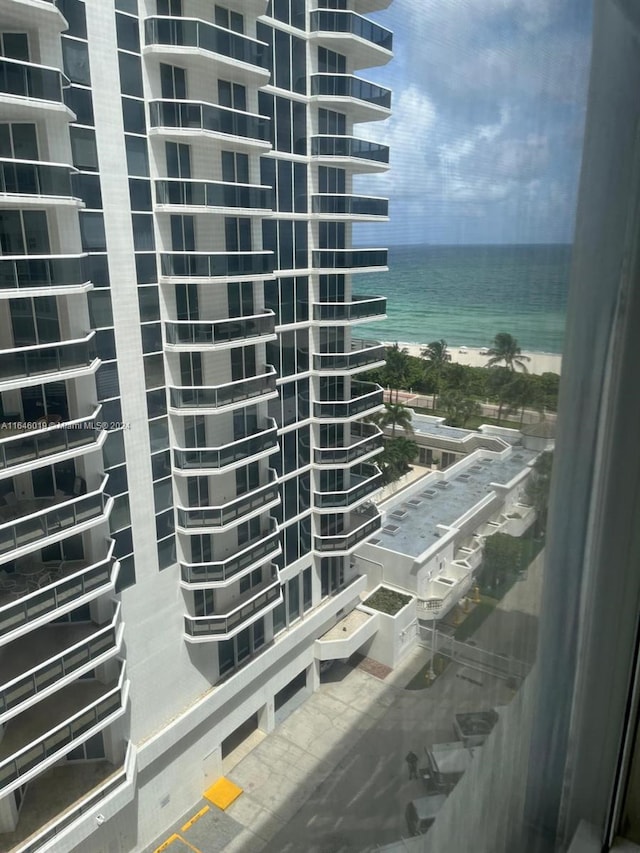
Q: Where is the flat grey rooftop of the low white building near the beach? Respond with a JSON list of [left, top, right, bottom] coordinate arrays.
[[368, 448, 538, 557]]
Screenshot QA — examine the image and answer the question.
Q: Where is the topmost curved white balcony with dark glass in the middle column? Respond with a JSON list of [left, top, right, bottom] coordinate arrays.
[[144, 17, 269, 83]]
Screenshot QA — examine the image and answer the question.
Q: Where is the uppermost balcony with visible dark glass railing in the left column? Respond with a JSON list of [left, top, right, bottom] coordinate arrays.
[[0, 57, 73, 119]]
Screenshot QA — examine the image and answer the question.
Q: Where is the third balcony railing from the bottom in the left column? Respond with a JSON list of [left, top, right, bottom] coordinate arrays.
[[0, 603, 120, 717]]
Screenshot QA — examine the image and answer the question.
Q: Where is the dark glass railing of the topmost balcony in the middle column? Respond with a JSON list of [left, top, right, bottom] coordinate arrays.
[[144, 17, 267, 70]]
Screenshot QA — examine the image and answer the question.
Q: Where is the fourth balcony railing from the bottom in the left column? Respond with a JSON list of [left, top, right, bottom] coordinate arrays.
[[0, 542, 118, 637]]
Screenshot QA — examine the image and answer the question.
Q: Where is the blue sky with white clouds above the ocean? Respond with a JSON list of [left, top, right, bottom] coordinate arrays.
[[354, 0, 591, 246]]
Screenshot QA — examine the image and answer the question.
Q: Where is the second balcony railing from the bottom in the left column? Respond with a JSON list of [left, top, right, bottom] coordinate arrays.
[[0, 664, 126, 793]]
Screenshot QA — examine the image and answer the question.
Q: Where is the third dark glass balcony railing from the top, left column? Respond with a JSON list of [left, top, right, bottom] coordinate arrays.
[[0, 255, 90, 295]]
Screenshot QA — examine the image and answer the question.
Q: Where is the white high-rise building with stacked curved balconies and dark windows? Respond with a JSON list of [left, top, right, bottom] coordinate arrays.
[[0, 0, 392, 853]]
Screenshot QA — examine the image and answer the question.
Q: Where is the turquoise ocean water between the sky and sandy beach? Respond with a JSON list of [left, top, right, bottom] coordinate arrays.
[[353, 245, 571, 353]]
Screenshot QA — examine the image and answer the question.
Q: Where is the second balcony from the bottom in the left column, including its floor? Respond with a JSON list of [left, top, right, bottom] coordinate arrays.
[[0, 664, 128, 794]]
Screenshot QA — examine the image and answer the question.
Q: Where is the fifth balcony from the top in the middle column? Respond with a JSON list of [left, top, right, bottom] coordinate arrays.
[[164, 311, 276, 352]]
